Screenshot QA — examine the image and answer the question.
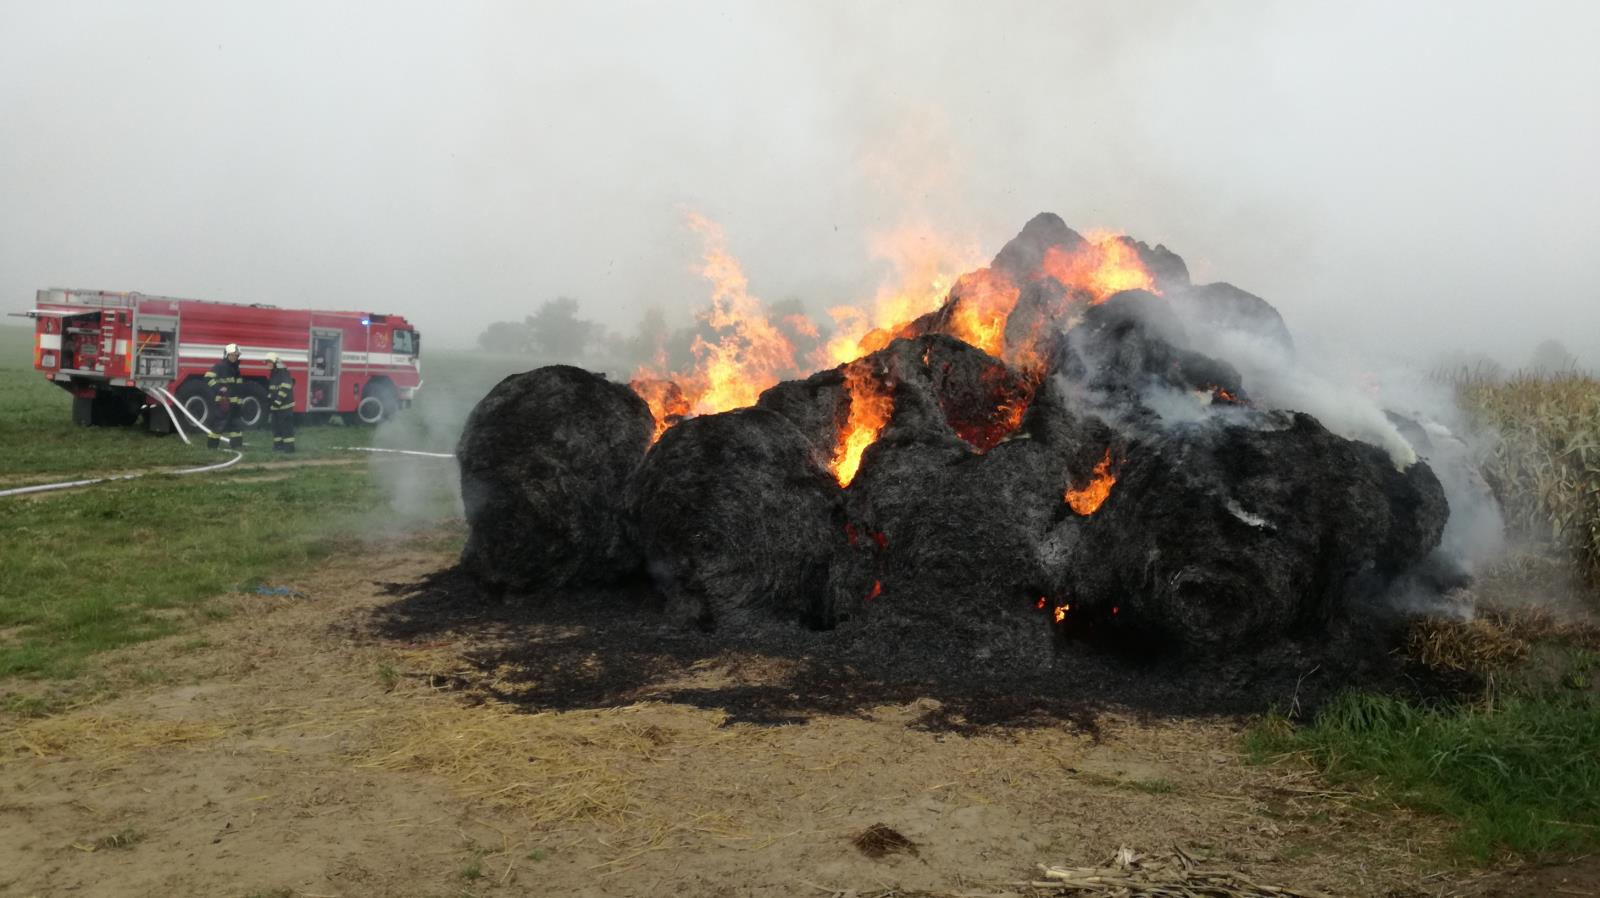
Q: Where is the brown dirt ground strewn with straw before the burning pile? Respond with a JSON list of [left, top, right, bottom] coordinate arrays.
[[0, 549, 1580, 898]]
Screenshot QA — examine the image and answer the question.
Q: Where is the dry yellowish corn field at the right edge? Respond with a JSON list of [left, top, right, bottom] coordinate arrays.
[[1450, 371, 1600, 587]]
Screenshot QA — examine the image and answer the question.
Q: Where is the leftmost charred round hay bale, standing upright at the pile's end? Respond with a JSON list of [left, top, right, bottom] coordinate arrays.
[[456, 365, 654, 589]]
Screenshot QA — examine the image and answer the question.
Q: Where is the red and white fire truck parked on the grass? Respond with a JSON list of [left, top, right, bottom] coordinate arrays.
[[26, 288, 422, 432]]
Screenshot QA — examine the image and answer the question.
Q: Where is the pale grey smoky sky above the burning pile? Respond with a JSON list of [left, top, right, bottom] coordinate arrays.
[[0, 0, 1600, 365]]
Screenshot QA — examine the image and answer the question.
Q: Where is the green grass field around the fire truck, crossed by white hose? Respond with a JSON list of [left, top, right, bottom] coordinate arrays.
[[0, 327, 526, 677]]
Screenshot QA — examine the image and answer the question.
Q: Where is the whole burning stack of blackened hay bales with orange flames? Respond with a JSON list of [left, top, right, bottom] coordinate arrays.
[[459, 214, 1448, 655]]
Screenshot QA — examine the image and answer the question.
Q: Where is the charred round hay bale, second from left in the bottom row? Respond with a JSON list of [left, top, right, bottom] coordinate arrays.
[[629, 408, 846, 629]]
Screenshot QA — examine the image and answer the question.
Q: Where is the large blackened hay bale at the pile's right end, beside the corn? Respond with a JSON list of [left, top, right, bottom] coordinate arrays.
[[1067, 413, 1448, 653]]
